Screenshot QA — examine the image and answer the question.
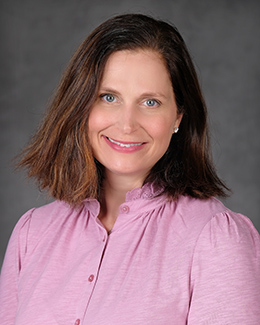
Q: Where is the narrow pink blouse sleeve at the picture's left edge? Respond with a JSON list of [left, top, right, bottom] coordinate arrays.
[[0, 210, 32, 325]]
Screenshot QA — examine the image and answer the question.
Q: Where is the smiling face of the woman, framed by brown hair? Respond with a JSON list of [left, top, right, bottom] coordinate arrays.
[[88, 50, 182, 186]]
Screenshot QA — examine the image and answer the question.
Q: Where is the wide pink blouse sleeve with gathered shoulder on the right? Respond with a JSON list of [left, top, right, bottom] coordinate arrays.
[[187, 211, 260, 325]]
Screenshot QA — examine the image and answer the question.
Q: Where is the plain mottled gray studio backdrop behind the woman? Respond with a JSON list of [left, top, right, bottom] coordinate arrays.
[[0, 0, 260, 265]]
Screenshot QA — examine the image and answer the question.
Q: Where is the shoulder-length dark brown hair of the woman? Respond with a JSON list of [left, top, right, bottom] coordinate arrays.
[[18, 14, 228, 205]]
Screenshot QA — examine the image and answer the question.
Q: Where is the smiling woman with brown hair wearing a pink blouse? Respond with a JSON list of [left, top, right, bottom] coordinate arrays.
[[0, 14, 260, 325]]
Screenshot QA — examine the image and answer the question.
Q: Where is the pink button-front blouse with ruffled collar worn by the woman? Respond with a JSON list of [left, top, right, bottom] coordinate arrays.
[[0, 184, 260, 325]]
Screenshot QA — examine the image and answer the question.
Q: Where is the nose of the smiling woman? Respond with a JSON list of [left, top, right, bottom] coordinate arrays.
[[118, 104, 139, 134]]
